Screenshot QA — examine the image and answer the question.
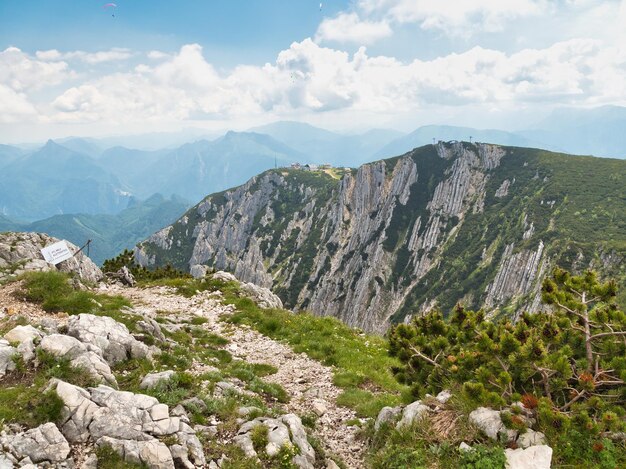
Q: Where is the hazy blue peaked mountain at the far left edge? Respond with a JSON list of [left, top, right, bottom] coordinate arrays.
[[0, 140, 129, 220]]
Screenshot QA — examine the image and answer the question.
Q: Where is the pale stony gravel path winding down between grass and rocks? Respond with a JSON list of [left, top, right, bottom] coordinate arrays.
[[107, 287, 365, 469]]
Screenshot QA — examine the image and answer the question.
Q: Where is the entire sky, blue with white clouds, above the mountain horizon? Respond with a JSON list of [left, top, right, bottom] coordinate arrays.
[[0, 0, 626, 143]]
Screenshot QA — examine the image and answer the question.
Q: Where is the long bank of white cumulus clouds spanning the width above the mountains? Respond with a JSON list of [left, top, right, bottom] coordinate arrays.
[[0, 35, 626, 131]]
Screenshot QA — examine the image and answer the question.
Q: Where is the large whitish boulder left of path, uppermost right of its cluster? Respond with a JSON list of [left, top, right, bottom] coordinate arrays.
[[67, 314, 150, 364]]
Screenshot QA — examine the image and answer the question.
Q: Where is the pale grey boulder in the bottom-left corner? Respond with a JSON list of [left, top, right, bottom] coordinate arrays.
[[8, 423, 70, 463]]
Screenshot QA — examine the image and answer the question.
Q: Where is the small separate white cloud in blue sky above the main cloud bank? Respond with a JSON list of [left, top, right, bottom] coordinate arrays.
[[315, 13, 392, 44]]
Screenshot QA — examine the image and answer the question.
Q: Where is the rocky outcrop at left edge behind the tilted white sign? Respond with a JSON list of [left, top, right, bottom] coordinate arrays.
[[0, 233, 103, 282]]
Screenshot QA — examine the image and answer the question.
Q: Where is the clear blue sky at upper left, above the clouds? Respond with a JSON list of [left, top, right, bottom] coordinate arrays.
[[0, 0, 338, 66]]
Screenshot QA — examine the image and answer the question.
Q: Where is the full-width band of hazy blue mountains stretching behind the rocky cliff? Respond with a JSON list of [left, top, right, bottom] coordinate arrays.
[[0, 106, 626, 221]]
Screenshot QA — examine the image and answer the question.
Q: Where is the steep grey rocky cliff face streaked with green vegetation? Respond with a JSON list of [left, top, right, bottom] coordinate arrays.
[[136, 142, 626, 331]]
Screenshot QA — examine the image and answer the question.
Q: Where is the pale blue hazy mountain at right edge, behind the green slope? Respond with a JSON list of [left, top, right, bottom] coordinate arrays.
[[519, 106, 626, 158]]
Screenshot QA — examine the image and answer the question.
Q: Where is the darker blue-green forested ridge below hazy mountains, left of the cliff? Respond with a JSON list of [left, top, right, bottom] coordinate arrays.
[[20, 194, 191, 265]]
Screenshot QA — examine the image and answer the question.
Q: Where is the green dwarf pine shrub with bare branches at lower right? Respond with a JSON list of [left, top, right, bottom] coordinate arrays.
[[389, 269, 626, 467]]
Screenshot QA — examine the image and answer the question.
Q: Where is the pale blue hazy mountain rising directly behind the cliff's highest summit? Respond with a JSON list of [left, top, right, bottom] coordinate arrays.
[[375, 125, 556, 159]]
